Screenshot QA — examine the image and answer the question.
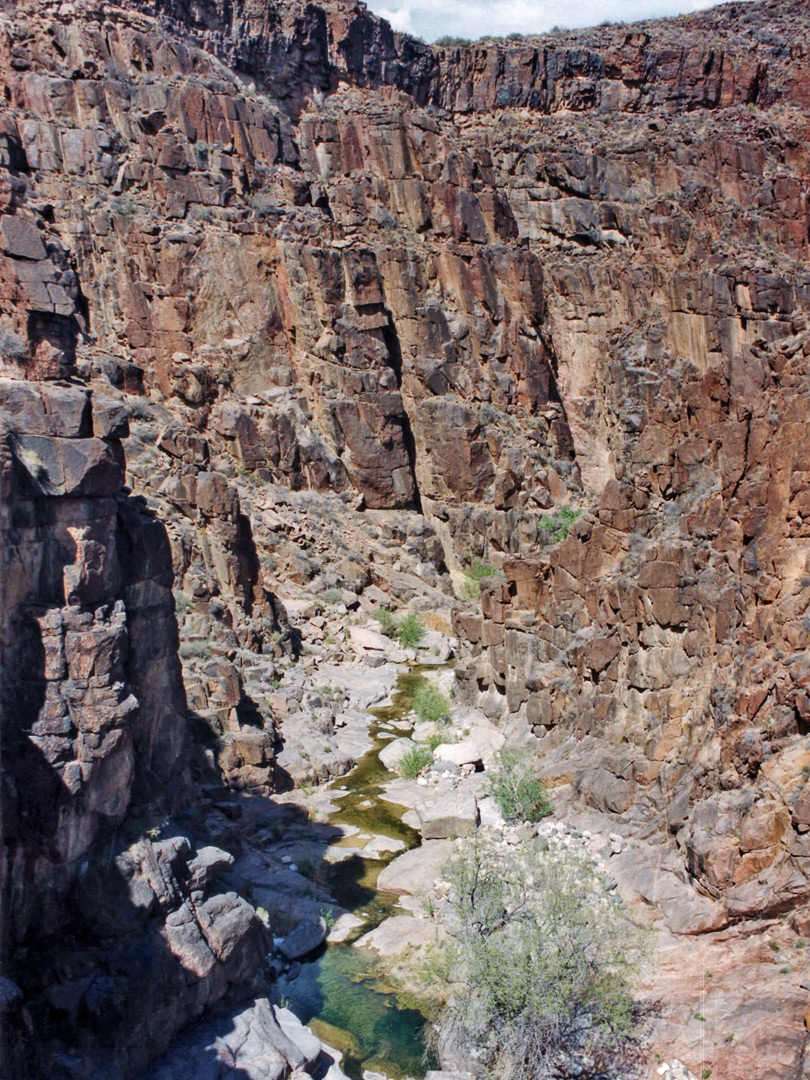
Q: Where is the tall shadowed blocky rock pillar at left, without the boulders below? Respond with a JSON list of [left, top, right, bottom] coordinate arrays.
[[0, 379, 186, 940]]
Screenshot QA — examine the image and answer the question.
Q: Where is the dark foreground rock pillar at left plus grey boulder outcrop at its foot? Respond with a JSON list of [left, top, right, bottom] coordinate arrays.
[[0, 379, 266, 1078]]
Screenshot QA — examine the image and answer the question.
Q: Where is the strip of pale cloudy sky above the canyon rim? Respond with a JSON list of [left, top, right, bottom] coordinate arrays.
[[366, 0, 747, 41]]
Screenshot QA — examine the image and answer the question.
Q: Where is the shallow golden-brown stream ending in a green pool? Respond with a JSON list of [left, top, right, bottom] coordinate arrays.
[[270, 666, 438, 1080]]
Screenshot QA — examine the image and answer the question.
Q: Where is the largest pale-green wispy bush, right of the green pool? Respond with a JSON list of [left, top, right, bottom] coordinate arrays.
[[427, 834, 642, 1080]]
